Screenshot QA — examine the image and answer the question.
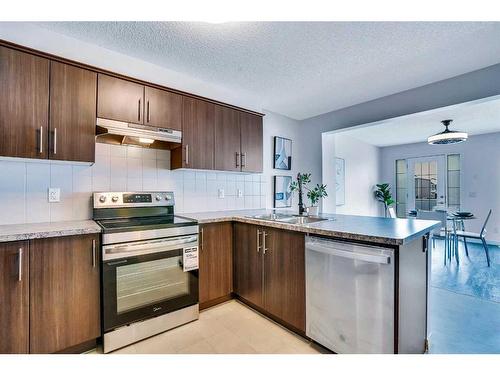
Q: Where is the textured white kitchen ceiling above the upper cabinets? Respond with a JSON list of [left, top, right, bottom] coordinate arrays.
[[37, 22, 500, 119]]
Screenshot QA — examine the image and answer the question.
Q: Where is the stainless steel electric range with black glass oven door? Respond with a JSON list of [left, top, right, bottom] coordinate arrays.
[[94, 192, 198, 353]]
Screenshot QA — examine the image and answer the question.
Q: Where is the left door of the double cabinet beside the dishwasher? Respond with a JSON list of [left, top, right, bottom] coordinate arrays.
[[233, 223, 263, 307]]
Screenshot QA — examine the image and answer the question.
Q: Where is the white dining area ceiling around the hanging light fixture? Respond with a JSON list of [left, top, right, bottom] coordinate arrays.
[[338, 98, 500, 147]]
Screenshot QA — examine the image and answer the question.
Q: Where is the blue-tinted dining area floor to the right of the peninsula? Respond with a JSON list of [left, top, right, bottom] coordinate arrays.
[[429, 240, 500, 354]]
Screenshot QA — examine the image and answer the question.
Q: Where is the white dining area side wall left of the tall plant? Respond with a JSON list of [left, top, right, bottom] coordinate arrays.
[[323, 133, 381, 216]]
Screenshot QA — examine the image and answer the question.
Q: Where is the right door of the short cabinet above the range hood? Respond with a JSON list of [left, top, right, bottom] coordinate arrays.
[[144, 86, 182, 130]]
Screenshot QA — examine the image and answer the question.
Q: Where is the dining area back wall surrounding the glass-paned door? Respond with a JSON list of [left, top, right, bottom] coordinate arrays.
[[381, 132, 500, 242]]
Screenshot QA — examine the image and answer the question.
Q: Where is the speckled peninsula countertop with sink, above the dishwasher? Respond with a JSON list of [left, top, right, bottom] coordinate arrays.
[[182, 209, 441, 245]]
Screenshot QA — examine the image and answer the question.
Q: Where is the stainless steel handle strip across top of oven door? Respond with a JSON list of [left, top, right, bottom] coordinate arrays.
[[102, 234, 198, 260]]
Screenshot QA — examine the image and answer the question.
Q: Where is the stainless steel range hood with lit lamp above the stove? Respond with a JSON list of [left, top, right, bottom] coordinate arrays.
[[96, 118, 182, 150]]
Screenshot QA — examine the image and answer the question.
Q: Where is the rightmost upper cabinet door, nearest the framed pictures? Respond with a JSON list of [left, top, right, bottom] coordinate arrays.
[[240, 112, 262, 172]]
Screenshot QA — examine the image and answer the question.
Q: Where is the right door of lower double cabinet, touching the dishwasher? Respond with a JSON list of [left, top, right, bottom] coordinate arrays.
[[264, 228, 306, 331]]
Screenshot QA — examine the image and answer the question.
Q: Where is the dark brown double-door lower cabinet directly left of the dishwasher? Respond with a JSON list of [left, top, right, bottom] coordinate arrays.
[[234, 223, 306, 332]]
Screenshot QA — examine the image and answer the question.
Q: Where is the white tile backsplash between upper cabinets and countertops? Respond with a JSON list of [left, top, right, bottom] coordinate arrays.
[[0, 143, 266, 224]]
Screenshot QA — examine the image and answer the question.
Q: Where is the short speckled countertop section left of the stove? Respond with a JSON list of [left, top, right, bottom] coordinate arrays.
[[0, 220, 101, 242]]
